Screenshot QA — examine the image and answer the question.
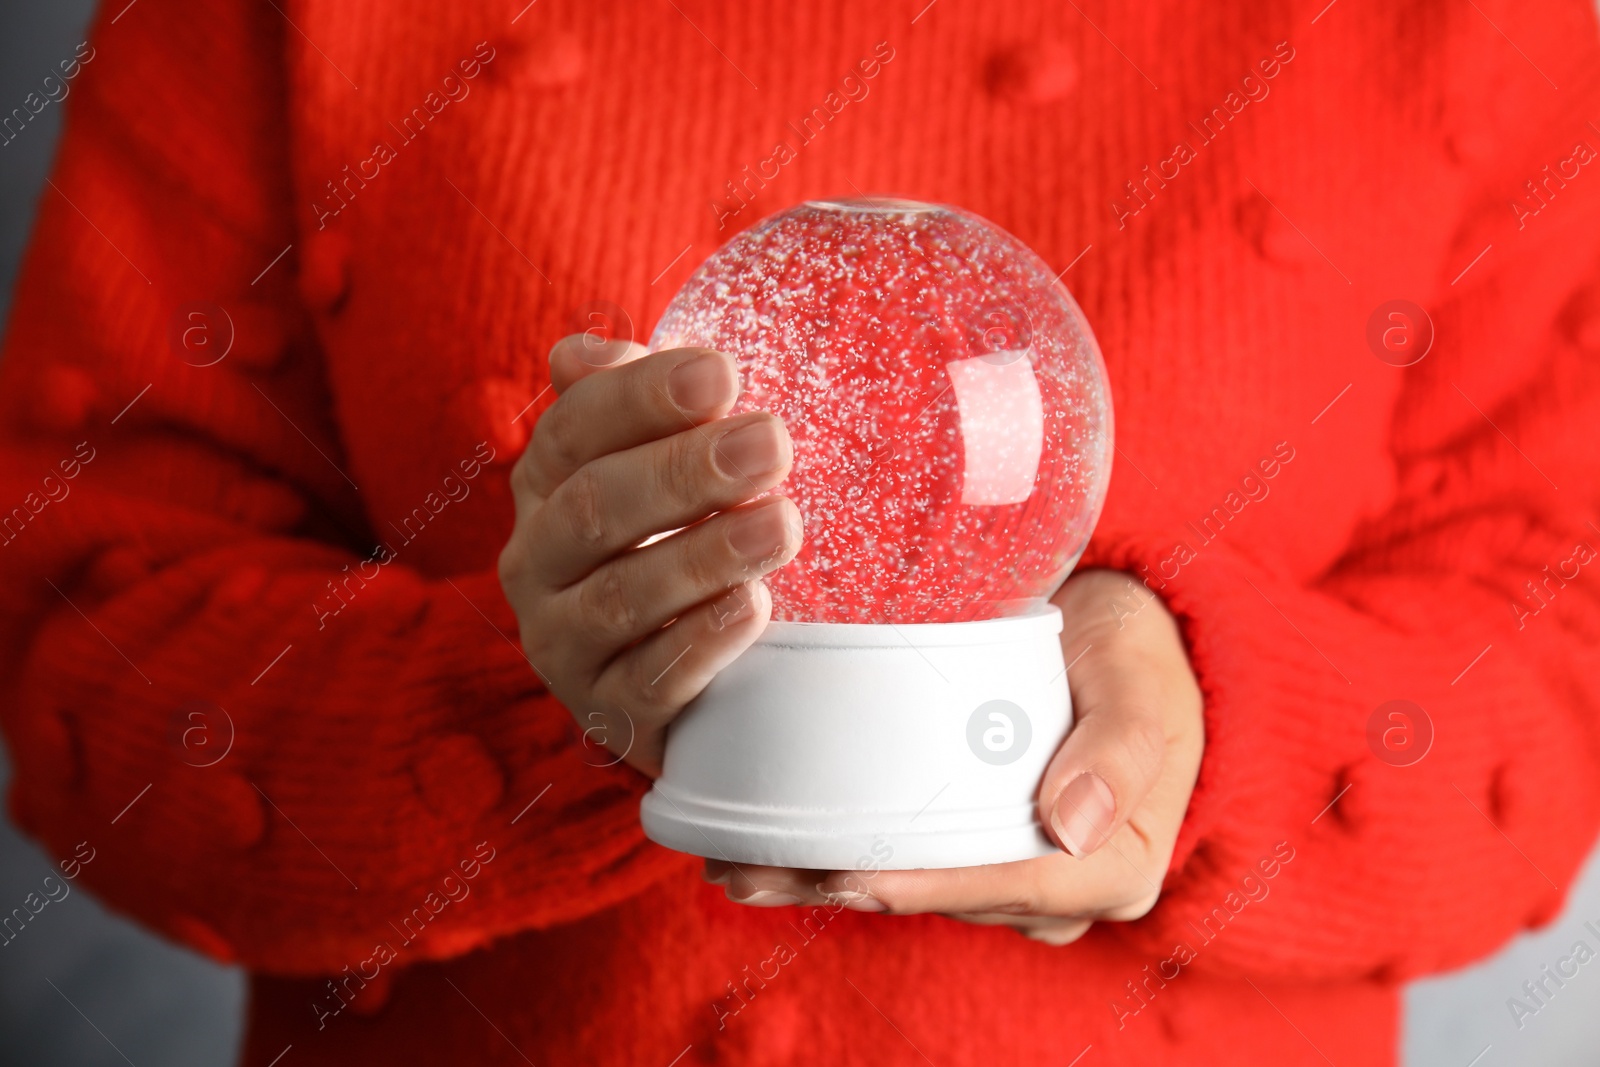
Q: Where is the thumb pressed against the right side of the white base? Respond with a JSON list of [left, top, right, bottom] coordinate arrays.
[[1038, 648, 1166, 859]]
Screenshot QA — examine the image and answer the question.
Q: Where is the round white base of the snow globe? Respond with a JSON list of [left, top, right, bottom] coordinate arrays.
[[640, 605, 1072, 870]]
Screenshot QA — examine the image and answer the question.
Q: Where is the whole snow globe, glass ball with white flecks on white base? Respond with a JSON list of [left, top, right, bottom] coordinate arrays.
[[642, 198, 1112, 869]]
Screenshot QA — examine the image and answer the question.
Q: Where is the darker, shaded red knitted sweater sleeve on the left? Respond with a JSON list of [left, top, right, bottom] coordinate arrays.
[[0, 0, 682, 973]]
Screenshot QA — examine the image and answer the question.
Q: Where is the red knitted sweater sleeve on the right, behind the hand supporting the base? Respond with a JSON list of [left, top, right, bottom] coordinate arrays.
[[1085, 96, 1600, 979]]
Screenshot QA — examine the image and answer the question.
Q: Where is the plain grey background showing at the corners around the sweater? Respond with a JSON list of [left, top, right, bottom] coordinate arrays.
[[0, 0, 1600, 1067]]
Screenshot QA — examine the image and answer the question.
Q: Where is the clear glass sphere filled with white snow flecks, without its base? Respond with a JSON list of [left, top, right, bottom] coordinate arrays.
[[650, 198, 1112, 624]]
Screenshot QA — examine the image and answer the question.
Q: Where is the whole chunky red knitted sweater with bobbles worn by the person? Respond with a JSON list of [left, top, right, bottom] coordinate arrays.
[[0, 0, 1600, 1067]]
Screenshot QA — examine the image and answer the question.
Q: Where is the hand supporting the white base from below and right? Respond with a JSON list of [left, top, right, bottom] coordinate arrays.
[[706, 571, 1205, 944]]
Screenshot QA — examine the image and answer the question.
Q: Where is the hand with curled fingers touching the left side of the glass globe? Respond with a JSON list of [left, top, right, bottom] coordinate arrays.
[[499, 334, 800, 777]]
